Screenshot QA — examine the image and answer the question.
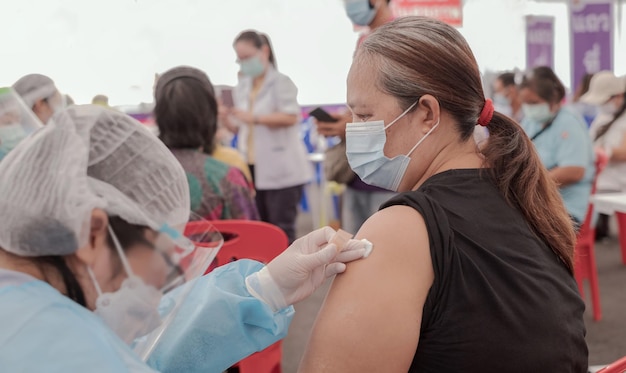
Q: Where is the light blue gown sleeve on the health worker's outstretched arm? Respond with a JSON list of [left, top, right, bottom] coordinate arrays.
[[148, 260, 294, 373]]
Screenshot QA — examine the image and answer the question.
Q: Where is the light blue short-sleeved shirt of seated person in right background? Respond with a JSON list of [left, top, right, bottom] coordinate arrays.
[[521, 107, 595, 223]]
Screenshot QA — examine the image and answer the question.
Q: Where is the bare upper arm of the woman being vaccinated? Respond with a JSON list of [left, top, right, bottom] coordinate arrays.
[[299, 206, 434, 373]]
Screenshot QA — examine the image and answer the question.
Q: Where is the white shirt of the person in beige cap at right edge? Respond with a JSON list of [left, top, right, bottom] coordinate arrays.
[[589, 114, 626, 192]]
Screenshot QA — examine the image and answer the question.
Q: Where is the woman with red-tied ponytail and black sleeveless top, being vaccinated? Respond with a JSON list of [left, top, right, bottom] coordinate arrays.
[[299, 17, 588, 373]]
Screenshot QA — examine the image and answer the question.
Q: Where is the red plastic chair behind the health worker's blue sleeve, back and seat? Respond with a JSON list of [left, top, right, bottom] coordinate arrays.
[[185, 220, 289, 373]]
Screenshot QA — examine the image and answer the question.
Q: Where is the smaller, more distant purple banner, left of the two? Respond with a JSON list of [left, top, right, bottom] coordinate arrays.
[[526, 16, 554, 69]]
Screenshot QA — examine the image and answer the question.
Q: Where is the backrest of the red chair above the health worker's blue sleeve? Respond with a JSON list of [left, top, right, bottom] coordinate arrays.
[[186, 220, 289, 269]]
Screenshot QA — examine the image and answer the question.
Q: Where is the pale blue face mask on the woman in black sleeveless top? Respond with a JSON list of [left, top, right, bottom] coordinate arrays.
[[346, 101, 439, 191]]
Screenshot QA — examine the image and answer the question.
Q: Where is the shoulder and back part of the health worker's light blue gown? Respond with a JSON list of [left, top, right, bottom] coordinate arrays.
[[0, 280, 153, 373]]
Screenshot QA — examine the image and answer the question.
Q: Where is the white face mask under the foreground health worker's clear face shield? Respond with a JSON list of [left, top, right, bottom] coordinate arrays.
[[87, 226, 163, 344]]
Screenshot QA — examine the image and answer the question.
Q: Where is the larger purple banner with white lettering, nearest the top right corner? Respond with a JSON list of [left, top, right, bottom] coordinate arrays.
[[570, 0, 614, 91]]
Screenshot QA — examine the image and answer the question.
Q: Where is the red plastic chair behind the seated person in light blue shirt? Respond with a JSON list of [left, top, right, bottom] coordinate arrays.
[[574, 149, 609, 321]]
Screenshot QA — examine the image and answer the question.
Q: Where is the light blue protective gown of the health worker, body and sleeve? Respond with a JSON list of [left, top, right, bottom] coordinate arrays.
[[0, 260, 294, 373]]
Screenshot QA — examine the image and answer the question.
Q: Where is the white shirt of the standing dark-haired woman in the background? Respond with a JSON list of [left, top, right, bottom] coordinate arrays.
[[233, 67, 313, 190]]
